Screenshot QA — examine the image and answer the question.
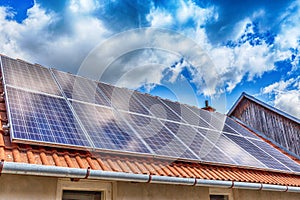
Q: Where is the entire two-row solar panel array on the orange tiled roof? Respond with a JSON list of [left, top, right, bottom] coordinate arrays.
[[1, 56, 300, 172]]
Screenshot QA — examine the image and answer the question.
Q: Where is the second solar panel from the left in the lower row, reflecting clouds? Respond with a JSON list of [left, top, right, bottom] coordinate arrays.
[[72, 101, 150, 153]]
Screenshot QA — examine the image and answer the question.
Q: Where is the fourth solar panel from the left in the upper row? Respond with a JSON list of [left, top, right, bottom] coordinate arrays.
[[133, 92, 181, 122]]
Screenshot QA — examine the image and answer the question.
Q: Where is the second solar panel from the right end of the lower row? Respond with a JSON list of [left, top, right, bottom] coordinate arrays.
[[225, 133, 290, 171]]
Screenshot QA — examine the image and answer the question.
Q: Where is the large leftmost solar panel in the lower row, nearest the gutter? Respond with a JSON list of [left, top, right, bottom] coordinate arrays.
[[6, 86, 91, 147]]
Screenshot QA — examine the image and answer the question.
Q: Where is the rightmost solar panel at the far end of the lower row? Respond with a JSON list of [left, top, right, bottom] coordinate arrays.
[[249, 139, 300, 172]]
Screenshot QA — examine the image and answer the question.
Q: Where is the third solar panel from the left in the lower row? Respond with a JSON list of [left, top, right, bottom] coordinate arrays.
[[122, 112, 198, 160]]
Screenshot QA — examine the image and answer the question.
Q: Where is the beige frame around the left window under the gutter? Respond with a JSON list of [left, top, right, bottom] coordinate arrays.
[[56, 179, 112, 200]]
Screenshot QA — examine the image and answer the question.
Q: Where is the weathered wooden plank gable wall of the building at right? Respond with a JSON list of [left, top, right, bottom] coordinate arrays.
[[230, 98, 300, 156]]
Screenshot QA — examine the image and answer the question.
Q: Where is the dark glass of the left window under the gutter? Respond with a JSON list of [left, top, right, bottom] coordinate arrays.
[[62, 190, 101, 200]]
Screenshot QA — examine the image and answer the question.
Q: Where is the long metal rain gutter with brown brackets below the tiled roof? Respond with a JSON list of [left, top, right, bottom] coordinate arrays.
[[0, 161, 300, 193]]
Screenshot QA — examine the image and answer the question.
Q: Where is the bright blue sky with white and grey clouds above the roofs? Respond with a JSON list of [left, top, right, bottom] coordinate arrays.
[[0, 0, 300, 118]]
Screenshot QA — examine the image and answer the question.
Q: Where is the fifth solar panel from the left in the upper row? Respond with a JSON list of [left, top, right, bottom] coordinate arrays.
[[160, 99, 210, 128]]
